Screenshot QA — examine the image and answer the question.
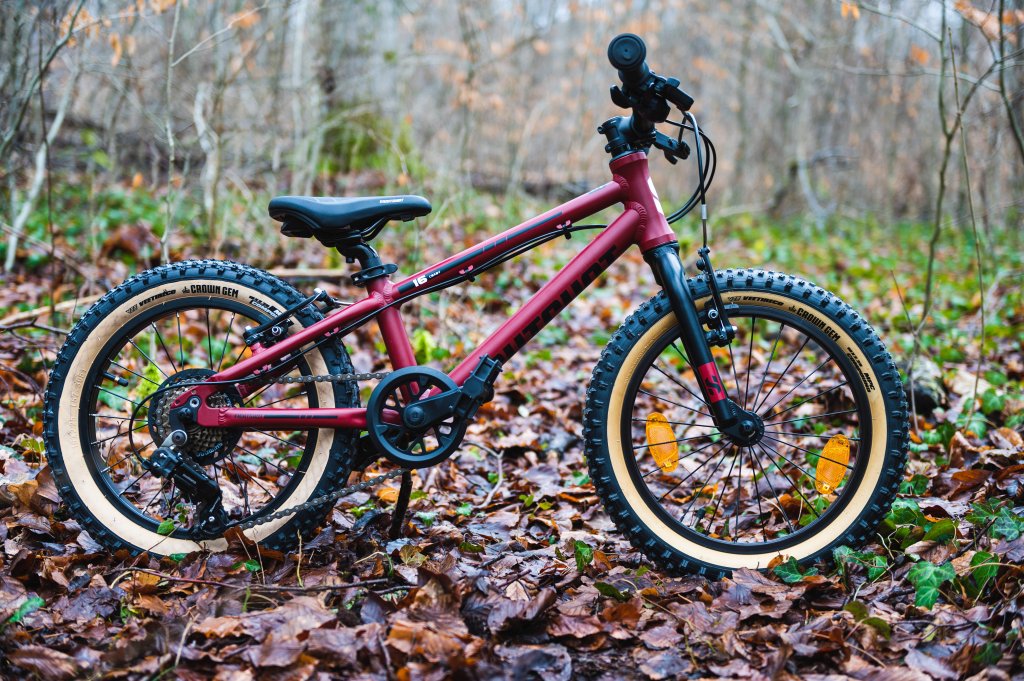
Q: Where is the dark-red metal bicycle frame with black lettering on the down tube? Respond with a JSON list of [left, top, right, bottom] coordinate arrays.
[[180, 152, 676, 429]]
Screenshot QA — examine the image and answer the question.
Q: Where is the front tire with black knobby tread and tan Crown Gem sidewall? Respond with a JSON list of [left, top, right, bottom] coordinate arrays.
[[584, 269, 908, 578]]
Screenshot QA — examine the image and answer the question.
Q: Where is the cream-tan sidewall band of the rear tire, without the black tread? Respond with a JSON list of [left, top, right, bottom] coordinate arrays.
[[57, 276, 335, 555]]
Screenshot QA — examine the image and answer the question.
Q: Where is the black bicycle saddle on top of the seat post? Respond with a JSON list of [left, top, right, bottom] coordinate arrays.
[[269, 196, 430, 248]]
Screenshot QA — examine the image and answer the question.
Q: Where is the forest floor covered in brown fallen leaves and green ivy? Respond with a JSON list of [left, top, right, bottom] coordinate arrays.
[[0, 184, 1024, 680]]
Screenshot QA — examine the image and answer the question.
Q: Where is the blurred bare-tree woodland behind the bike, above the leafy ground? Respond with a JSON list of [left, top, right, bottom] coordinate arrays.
[[0, 0, 1024, 273]]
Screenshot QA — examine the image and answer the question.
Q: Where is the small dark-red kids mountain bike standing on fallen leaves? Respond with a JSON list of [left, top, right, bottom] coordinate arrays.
[[44, 34, 907, 577]]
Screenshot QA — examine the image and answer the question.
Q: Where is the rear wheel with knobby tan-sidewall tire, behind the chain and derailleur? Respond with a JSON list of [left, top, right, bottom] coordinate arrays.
[[44, 261, 358, 555]]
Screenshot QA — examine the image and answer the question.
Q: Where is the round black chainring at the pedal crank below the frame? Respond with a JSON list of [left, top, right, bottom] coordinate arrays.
[[367, 367, 466, 469]]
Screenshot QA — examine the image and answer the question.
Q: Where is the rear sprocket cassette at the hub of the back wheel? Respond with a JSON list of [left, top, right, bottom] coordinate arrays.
[[147, 369, 243, 466]]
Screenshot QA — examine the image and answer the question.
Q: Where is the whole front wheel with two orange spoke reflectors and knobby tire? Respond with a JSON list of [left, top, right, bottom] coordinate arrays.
[[585, 269, 908, 578]]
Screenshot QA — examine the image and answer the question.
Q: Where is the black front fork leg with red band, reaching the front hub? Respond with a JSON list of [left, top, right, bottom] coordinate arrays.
[[643, 241, 761, 440]]
